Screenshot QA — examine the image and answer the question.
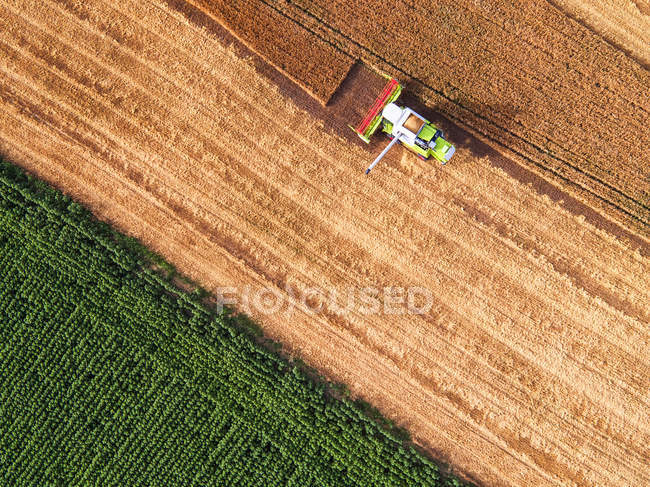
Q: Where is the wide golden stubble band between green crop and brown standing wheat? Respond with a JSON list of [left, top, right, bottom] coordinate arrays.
[[0, 0, 650, 486]]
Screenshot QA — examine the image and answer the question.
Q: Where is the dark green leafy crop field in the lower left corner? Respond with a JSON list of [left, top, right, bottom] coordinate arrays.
[[0, 161, 460, 487]]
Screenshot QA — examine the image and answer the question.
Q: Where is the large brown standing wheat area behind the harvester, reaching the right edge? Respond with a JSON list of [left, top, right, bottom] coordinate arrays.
[[204, 0, 650, 235]]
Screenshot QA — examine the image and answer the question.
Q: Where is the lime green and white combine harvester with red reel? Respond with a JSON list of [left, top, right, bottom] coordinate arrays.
[[350, 78, 456, 174]]
